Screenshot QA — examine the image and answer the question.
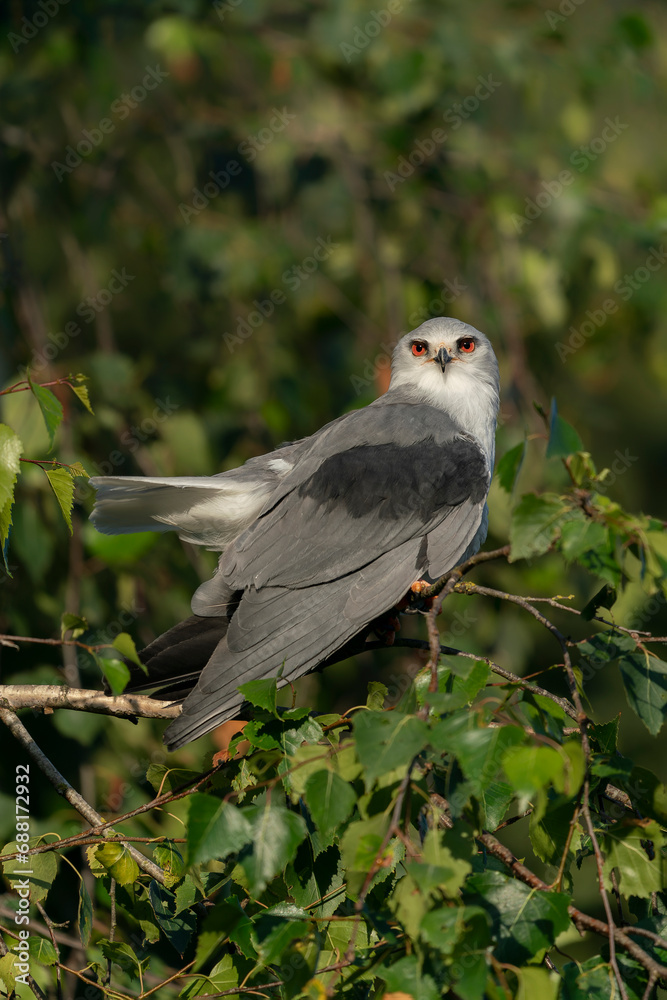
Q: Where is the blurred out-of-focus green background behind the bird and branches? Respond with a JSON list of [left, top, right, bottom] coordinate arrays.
[[0, 0, 667, 860]]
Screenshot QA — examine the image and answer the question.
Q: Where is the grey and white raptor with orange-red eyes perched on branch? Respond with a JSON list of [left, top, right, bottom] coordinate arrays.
[[91, 317, 500, 750]]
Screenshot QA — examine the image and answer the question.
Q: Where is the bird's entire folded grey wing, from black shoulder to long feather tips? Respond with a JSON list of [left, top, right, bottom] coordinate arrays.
[[165, 405, 489, 747]]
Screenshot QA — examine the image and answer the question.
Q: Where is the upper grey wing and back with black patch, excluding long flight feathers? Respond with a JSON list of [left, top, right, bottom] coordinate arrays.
[[220, 404, 490, 590]]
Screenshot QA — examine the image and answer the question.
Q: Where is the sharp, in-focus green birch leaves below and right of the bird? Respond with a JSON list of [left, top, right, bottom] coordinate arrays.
[[0, 394, 667, 1000]]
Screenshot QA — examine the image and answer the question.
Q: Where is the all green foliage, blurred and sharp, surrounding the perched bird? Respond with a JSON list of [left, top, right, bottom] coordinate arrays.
[[0, 0, 667, 1000]]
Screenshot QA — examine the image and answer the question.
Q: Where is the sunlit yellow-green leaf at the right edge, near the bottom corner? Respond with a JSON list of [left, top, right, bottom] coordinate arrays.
[[602, 820, 667, 898]]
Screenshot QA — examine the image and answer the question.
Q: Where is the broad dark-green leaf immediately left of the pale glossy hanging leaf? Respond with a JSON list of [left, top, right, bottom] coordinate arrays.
[[188, 792, 253, 865]]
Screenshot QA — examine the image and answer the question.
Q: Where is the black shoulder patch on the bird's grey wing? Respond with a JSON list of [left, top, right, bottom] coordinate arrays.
[[299, 437, 489, 522]]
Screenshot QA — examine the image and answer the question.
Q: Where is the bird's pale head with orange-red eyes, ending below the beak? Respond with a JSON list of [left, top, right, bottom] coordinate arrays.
[[390, 317, 499, 409]]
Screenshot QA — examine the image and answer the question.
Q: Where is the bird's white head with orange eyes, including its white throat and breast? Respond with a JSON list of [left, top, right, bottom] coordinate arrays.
[[389, 317, 500, 468]]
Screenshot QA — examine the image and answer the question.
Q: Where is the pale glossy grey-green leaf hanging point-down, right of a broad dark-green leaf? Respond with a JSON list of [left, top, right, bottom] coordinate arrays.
[[239, 795, 307, 897]]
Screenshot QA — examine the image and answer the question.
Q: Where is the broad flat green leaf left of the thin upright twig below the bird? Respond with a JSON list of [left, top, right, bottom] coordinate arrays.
[[354, 711, 429, 790]]
